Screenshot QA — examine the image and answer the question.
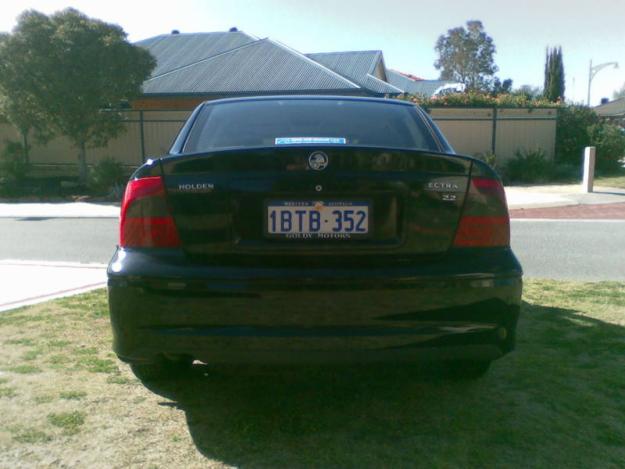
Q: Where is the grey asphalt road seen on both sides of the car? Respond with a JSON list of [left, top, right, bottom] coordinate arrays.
[[0, 218, 625, 280]]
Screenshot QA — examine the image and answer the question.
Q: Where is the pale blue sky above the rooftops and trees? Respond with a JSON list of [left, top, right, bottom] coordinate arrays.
[[0, 0, 625, 105]]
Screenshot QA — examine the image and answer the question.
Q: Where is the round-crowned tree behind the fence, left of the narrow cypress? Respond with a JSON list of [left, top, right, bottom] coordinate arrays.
[[434, 20, 499, 91]]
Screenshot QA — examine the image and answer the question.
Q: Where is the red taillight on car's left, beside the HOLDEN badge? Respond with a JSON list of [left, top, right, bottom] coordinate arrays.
[[119, 176, 180, 248]]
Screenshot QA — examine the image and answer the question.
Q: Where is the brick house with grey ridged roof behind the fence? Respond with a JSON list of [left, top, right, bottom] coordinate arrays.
[[133, 30, 403, 109]]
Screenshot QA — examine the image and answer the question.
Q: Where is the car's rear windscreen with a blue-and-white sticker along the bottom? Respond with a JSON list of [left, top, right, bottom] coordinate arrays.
[[184, 99, 438, 153]]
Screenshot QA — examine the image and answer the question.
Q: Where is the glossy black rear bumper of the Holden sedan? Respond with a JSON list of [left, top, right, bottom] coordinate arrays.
[[108, 249, 522, 363]]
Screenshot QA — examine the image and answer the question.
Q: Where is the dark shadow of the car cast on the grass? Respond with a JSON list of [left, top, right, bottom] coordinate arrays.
[[139, 303, 625, 467]]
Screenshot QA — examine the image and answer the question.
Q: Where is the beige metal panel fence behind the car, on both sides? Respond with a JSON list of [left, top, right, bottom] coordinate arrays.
[[0, 108, 557, 175]]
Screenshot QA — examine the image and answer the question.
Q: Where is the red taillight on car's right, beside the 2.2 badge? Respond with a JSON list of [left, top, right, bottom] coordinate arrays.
[[454, 177, 510, 247]]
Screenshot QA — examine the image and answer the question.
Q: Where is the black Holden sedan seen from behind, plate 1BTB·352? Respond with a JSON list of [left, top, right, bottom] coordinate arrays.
[[108, 96, 522, 377]]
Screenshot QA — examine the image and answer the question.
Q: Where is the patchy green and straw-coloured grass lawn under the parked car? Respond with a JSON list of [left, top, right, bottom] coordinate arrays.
[[0, 280, 625, 468]]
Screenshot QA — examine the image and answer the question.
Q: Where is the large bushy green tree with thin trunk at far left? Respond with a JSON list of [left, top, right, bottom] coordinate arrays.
[[2, 8, 155, 183]]
